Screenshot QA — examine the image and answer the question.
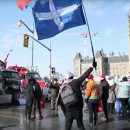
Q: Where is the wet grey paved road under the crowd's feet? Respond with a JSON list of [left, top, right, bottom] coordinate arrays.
[[0, 103, 130, 130]]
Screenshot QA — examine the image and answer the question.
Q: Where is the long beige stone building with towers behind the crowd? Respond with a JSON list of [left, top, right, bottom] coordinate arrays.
[[74, 12, 130, 76]]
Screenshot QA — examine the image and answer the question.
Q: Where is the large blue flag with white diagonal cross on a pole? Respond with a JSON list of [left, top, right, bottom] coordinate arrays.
[[32, 0, 86, 40]]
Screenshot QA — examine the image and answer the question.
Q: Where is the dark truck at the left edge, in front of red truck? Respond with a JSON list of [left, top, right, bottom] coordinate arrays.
[[0, 68, 21, 104]]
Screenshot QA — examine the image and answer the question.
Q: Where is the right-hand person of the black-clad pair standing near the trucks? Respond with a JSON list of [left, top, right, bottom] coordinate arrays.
[[32, 78, 43, 120]]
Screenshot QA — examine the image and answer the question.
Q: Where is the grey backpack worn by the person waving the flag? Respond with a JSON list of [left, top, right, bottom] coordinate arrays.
[[60, 84, 78, 108]]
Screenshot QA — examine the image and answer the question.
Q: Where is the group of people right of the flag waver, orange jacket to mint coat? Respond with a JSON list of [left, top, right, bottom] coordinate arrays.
[[85, 72, 130, 126]]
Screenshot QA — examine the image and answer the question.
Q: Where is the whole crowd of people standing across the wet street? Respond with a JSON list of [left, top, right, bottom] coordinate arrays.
[[26, 62, 130, 130]]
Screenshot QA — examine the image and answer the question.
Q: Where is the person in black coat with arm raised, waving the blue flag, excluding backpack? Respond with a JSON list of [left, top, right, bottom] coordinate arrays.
[[62, 67, 93, 130]]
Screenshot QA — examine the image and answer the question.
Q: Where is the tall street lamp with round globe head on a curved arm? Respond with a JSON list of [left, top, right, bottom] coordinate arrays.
[[17, 20, 34, 71]]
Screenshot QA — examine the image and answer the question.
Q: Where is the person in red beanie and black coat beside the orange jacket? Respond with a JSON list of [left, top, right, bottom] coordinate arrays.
[[99, 74, 110, 122]]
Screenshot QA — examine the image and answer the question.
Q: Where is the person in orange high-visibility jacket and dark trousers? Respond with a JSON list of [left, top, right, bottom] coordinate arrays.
[[85, 75, 99, 126]]
